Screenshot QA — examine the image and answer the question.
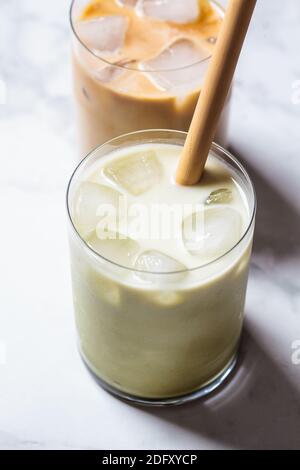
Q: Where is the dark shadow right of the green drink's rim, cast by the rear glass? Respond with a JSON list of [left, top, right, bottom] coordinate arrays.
[[229, 146, 300, 259]]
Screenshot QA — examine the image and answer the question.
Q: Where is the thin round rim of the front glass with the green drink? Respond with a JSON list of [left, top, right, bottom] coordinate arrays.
[[66, 129, 257, 276]]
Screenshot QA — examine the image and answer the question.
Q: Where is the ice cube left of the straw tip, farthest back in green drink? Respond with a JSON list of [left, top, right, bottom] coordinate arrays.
[[103, 150, 163, 196]]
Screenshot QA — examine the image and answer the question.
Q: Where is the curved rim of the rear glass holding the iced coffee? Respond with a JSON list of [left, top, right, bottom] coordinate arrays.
[[69, 0, 225, 73]]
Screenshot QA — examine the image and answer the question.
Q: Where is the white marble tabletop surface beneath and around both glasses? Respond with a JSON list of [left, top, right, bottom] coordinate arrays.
[[0, 0, 300, 449]]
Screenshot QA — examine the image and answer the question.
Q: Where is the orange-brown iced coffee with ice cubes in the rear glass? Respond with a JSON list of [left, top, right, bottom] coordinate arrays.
[[71, 0, 229, 156]]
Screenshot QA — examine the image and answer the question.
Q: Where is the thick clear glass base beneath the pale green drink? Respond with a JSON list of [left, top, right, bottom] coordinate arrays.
[[80, 351, 237, 407]]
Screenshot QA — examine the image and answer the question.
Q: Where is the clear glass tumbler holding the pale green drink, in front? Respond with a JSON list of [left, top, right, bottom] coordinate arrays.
[[67, 130, 256, 406]]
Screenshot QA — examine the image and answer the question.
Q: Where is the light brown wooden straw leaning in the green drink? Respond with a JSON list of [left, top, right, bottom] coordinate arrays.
[[176, 0, 256, 185]]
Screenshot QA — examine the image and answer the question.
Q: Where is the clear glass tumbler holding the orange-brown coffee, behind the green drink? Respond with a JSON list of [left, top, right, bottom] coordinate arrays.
[[70, 0, 230, 156]]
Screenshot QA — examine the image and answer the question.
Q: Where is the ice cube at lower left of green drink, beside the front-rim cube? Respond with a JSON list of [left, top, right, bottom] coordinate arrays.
[[86, 230, 140, 268]]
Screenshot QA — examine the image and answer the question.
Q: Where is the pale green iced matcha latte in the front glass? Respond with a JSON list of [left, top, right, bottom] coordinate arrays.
[[68, 131, 255, 404]]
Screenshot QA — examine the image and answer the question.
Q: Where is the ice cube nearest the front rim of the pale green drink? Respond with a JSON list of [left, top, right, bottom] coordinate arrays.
[[135, 250, 186, 282]]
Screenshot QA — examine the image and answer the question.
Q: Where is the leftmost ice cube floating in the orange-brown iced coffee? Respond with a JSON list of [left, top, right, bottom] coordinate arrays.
[[77, 15, 129, 55]]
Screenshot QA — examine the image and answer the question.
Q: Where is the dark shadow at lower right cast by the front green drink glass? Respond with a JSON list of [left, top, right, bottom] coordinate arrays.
[[139, 321, 300, 450]]
